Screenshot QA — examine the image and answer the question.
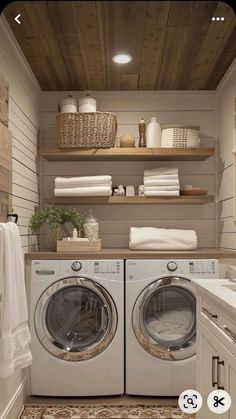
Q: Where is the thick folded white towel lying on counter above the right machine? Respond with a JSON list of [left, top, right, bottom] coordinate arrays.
[[129, 227, 197, 250]]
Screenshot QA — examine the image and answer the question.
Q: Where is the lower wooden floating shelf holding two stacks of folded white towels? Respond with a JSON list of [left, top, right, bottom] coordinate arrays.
[[44, 195, 214, 205]]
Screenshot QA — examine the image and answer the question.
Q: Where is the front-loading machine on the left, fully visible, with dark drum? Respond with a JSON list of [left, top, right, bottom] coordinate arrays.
[[30, 260, 124, 397]]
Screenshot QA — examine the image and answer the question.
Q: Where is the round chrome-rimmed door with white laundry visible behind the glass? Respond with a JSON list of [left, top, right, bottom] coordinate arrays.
[[133, 277, 196, 360]]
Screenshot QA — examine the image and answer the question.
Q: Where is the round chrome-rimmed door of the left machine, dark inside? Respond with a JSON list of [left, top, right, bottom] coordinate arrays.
[[35, 277, 117, 361]]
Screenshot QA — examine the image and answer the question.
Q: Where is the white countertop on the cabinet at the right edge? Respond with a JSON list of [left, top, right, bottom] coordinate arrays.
[[191, 278, 236, 318]]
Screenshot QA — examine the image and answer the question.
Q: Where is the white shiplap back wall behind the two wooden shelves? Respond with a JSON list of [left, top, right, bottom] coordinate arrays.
[[40, 91, 217, 247]]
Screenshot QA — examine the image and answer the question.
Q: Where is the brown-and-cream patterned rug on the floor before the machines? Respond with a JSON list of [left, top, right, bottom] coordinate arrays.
[[21, 404, 195, 419]]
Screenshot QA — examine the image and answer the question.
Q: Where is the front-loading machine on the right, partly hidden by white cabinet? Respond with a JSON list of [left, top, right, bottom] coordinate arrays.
[[126, 259, 219, 396]]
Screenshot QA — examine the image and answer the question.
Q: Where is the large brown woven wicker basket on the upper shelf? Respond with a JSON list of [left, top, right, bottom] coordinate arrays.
[[57, 112, 117, 148]]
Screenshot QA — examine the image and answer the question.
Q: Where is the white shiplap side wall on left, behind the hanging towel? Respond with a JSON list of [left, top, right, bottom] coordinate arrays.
[[0, 16, 40, 418]]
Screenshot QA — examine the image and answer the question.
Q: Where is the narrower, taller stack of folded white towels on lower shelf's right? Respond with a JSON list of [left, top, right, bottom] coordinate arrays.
[[143, 167, 180, 196]]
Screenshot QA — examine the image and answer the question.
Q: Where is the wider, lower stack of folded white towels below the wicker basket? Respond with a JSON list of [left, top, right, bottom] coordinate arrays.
[[54, 175, 112, 196]]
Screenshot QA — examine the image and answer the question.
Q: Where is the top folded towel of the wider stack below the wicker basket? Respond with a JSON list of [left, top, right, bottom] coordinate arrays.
[[55, 175, 111, 188]]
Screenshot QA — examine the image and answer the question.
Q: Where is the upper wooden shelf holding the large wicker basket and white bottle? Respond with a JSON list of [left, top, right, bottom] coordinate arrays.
[[40, 147, 215, 161]]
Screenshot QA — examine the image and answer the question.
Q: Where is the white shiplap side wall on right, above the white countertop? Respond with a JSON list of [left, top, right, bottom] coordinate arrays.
[[217, 60, 236, 249]]
